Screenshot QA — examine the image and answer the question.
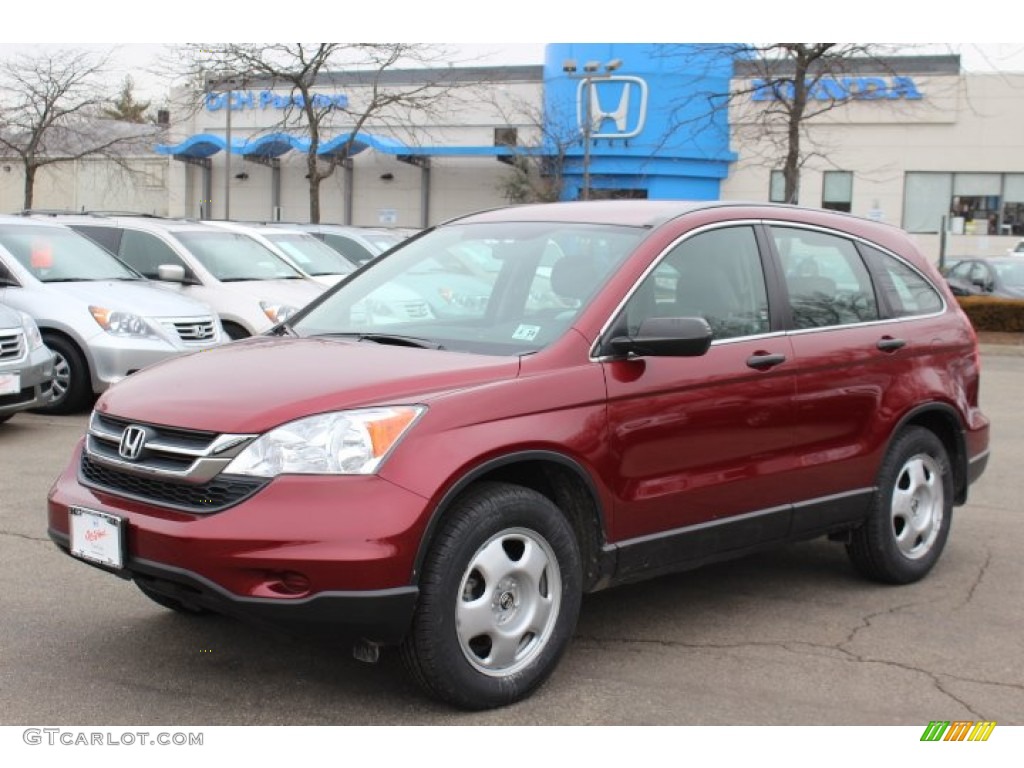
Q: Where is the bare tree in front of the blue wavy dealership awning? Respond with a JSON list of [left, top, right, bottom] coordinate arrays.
[[183, 43, 473, 223]]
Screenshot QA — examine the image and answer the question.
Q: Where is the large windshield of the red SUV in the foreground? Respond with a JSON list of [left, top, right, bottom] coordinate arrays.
[[293, 222, 647, 354]]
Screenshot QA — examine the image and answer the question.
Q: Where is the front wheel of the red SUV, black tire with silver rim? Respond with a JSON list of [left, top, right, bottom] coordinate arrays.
[[401, 482, 582, 710]]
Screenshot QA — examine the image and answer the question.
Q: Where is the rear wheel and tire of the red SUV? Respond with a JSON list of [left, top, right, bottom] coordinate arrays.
[[847, 427, 953, 584]]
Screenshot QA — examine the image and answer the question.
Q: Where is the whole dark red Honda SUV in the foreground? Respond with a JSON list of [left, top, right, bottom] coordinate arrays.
[[49, 201, 988, 708]]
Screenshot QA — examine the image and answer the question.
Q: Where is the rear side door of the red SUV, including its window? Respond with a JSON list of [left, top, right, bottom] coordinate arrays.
[[768, 224, 941, 536]]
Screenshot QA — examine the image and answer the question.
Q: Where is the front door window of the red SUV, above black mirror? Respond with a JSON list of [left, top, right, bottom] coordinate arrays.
[[626, 226, 770, 340]]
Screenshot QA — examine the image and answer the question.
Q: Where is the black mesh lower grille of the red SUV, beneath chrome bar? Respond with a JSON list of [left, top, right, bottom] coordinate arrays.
[[80, 454, 269, 514]]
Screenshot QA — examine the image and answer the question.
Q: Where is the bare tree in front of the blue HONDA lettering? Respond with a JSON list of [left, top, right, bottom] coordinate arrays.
[[660, 43, 912, 204]]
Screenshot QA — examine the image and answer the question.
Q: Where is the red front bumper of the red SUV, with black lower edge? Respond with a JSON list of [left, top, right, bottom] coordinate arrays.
[[48, 443, 426, 644]]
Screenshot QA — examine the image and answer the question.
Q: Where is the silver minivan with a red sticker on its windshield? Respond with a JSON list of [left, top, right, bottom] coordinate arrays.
[[0, 216, 224, 414]]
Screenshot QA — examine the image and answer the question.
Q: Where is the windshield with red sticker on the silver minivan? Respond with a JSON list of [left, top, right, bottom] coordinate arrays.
[[0, 225, 142, 283]]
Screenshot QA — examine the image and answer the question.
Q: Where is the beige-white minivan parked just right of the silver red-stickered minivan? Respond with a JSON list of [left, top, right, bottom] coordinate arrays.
[[43, 214, 325, 339]]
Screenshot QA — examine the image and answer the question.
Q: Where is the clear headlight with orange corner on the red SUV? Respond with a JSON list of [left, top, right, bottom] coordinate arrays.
[[224, 406, 426, 477]]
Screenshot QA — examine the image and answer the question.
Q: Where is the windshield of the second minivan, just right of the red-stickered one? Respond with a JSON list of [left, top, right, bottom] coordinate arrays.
[[174, 231, 302, 283]]
